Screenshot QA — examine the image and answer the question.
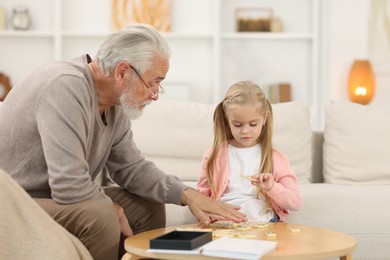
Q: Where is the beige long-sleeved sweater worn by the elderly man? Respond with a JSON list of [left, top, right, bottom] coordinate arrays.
[[0, 55, 186, 204]]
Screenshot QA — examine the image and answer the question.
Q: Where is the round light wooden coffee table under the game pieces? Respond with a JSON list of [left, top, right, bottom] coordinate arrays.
[[122, 222, 356, 260]]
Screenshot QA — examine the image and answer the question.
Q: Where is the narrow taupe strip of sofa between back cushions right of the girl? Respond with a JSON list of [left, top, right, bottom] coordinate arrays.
[[311, 131, 324, 183]]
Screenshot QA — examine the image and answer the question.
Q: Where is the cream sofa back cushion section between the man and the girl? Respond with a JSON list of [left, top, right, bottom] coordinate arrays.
[[132, 100, 214, 181]]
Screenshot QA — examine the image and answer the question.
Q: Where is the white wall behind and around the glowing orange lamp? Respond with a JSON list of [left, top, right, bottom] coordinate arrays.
[[320, 0, 390, 128]]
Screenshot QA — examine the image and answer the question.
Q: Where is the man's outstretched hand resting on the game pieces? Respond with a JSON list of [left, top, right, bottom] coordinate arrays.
[[181, 188, 247, 225]]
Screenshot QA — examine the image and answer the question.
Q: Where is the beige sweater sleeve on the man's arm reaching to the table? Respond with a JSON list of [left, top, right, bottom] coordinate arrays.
[[106, 118, 188, 205]]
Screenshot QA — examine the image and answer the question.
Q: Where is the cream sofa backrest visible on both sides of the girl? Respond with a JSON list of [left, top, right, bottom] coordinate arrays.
[[132, 100, 312, 183]]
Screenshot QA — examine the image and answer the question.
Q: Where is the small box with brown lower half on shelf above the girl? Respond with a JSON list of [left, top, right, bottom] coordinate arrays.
[[236, 8, 272, 32]]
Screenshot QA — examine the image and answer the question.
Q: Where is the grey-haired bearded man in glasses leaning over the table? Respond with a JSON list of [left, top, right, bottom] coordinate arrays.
[[0, 24, 246, 260]]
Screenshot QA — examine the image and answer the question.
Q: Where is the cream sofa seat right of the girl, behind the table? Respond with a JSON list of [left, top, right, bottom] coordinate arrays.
[[287, 183, 390, 260]]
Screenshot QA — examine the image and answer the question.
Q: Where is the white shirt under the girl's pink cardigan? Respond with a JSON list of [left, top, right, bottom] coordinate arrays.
[[221, 144, 273, 222]]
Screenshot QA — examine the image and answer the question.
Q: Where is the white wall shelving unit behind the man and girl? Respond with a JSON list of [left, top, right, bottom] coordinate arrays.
[[0, 0, 321, 127]]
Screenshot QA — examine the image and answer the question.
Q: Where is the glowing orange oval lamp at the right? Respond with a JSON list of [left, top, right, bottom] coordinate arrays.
[[348, 60, 375, 105]]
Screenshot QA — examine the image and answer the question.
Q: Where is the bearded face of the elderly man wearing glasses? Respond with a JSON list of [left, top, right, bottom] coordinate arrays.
[[120, 57, 169, 119]]
